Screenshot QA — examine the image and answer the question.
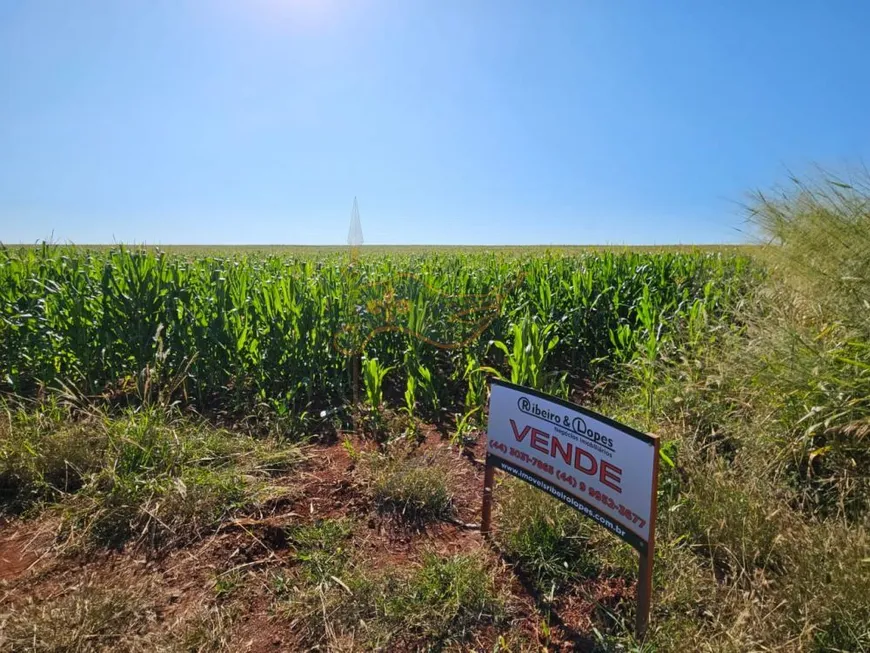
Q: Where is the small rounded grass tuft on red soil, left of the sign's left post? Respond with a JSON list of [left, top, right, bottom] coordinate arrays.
[[360, 445, 454, 524]]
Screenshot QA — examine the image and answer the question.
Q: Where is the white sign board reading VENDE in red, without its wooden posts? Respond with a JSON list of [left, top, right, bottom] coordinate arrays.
[[487, 380, 658, 554]]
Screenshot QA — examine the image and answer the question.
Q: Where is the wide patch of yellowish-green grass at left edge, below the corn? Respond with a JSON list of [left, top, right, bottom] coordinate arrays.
[[0, 402, 302, 549]]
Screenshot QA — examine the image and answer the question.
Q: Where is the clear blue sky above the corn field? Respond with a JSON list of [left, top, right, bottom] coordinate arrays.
[[0, 0, 870, 244]]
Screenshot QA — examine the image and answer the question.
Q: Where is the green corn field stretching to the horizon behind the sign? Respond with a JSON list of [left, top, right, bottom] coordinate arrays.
[[0, 246, 759, 414]]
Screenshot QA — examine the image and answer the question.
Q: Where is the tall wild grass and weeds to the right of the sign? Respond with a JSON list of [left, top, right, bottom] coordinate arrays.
[[605, 171, 870, 651]]
